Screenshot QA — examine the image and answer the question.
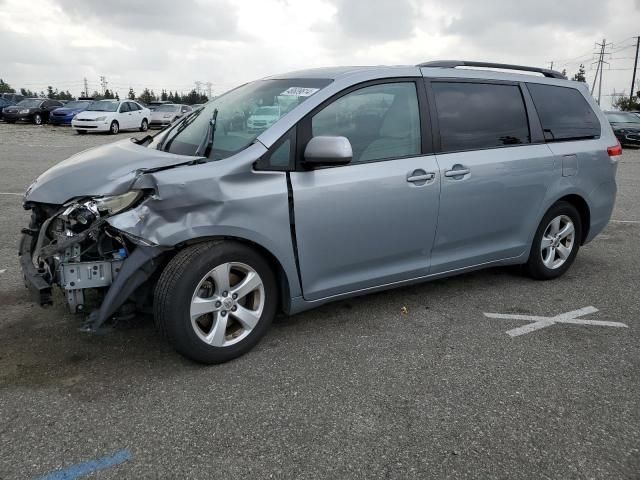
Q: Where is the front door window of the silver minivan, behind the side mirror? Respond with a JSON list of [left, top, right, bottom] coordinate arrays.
[[311, 82, 421, 163]]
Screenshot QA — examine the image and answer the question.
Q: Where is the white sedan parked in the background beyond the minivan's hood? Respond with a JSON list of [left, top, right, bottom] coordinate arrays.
[[71, 100, 151, 134]]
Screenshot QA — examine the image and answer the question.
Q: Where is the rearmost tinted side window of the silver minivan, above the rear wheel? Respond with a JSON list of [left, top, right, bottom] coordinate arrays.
[[527, 83, 600, 142]]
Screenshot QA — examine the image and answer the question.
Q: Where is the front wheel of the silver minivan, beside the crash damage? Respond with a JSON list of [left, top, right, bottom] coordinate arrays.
[[153, 241, 278, 364]]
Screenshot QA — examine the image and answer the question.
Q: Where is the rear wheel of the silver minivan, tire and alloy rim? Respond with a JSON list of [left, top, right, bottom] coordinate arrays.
[[525, 202, 582, 280]]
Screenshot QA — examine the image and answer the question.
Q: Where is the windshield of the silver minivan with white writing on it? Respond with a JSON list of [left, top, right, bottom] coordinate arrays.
[[156, 78, 331, 160]]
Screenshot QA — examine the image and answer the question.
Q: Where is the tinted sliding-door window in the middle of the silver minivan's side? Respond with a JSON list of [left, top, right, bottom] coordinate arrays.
[[432, 82, 531, 152]]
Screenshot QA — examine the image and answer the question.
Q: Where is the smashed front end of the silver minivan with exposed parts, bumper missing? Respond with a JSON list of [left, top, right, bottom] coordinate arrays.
[[19, 190, 163, 330]]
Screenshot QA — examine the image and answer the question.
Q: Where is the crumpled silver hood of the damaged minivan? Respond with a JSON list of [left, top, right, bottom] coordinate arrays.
[[24, 139, 196, 205]]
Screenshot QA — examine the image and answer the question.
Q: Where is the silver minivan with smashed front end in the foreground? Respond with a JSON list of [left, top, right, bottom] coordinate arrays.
[[20, 61, 621, 363]]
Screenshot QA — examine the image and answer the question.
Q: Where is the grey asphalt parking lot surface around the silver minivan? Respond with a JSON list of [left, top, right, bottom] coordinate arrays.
[[0, 123, 640, 480]]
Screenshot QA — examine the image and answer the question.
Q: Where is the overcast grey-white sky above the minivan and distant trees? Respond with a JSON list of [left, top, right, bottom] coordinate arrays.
[[0, 0, 640, 106]]
